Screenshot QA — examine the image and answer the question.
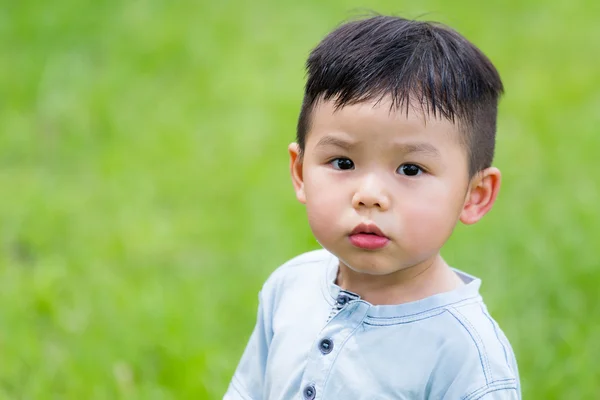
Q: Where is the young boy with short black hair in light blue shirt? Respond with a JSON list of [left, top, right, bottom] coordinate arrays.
[[225, 16, 520, 400]]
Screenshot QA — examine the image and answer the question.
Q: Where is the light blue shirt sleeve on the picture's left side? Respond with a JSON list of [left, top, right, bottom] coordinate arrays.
[[223, 293, 273, 400]]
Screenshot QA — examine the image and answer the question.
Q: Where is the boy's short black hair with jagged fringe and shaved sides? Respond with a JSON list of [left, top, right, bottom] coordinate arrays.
[[297, 15, 504, 176]]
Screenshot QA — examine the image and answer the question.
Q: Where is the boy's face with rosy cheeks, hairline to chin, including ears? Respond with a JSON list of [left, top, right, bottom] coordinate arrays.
[[289, 99, 499, 275]]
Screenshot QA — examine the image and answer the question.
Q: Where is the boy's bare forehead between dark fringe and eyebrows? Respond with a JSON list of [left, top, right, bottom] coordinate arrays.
[[306, 98, 464, 151]]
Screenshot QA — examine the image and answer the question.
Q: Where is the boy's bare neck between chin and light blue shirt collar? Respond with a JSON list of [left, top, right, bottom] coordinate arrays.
[[337, 254, 463, 305]]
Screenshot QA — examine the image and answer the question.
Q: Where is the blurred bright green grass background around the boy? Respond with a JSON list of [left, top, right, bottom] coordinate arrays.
[[0, 0, 600, 400]]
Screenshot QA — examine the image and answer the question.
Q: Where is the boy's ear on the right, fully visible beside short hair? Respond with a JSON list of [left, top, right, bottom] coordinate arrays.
[[460, 167, 502, 225]]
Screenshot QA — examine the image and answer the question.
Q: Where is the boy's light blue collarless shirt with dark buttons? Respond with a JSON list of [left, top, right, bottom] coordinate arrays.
[[224, 250, 521, 400]]
